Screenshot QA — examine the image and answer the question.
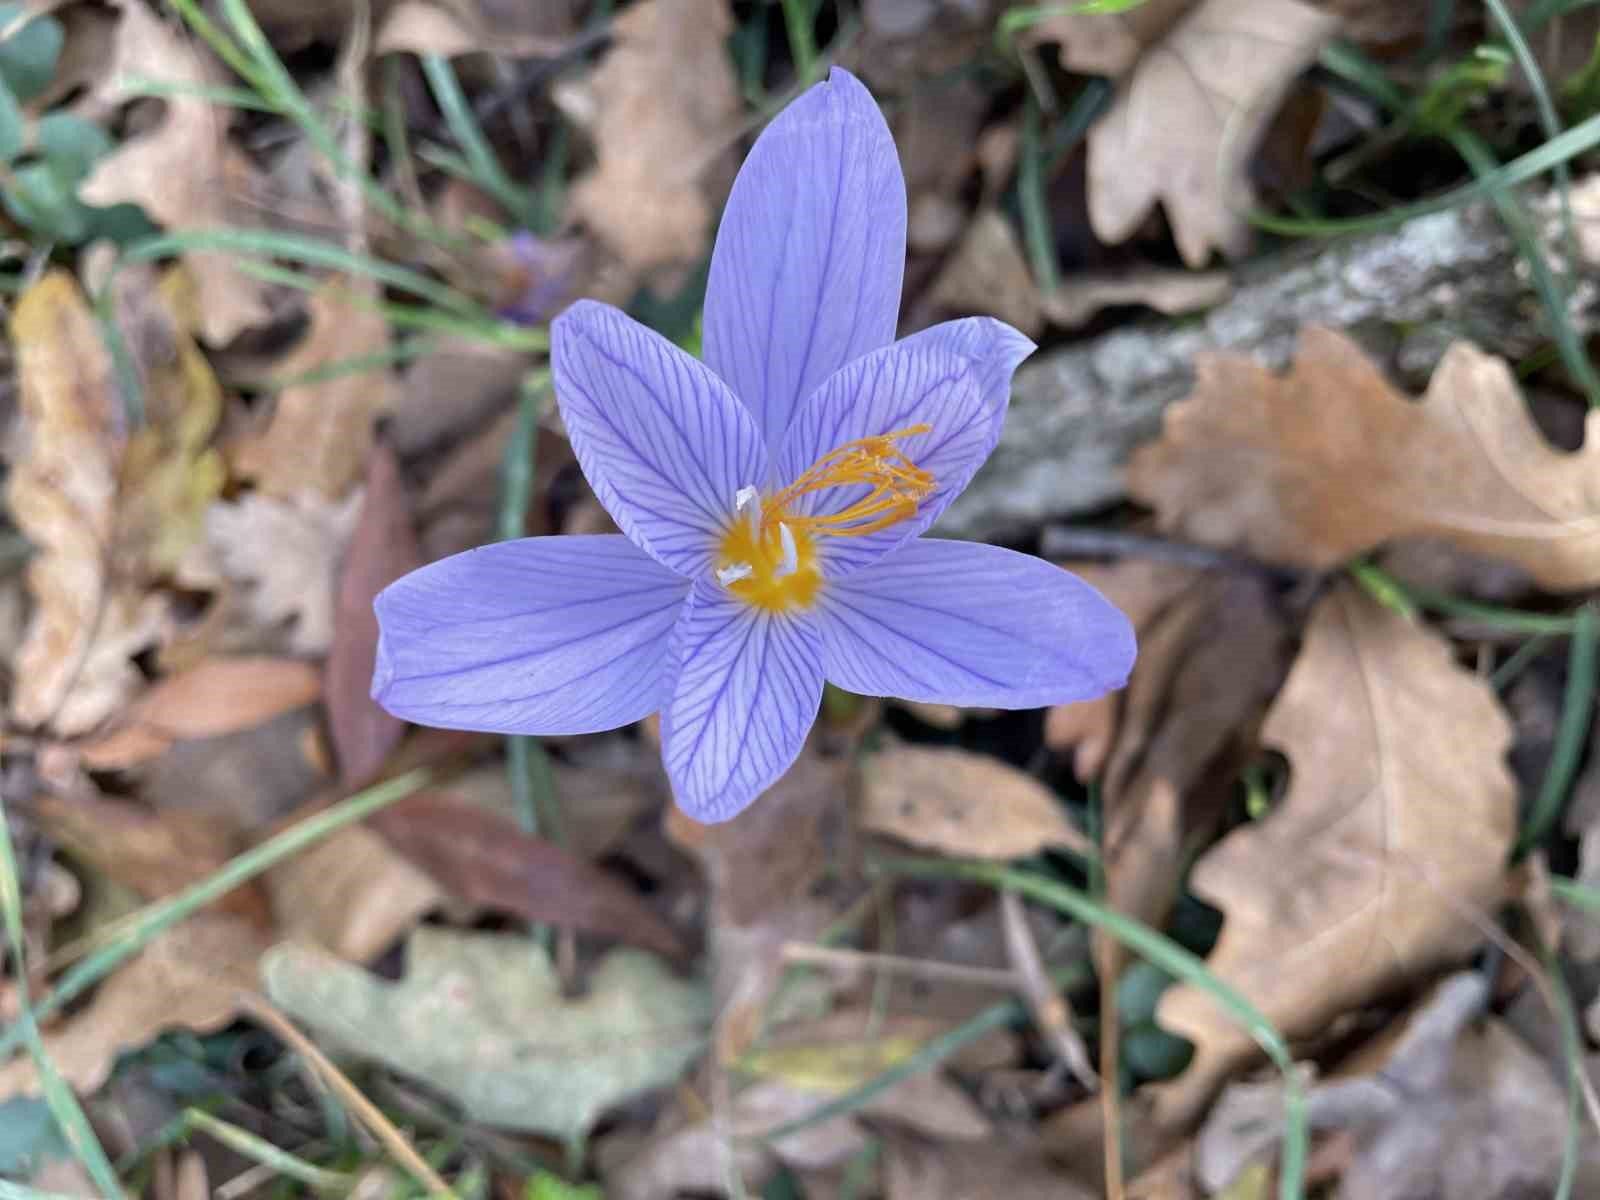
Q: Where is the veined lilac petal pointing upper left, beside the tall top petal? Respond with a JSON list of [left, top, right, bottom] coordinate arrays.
[[550, 301, 766, 576]]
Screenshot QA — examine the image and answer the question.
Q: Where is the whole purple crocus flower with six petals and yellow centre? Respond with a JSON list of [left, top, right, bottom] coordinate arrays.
[[373, 69, 1134, 821]]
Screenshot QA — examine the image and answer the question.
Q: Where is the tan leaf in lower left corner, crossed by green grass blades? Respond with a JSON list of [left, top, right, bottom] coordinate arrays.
[[0, 914, 266, 1104]]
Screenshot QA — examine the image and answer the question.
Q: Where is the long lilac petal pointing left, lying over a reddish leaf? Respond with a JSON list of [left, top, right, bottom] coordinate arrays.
[[373, 534, 690, 734]]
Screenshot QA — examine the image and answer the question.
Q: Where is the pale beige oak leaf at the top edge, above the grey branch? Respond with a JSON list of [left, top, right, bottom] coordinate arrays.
[[1088, 0, 1339, 267]]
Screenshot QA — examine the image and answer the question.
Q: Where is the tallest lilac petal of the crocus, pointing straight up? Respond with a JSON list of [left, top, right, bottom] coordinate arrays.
[[704, 67, 906, 450]]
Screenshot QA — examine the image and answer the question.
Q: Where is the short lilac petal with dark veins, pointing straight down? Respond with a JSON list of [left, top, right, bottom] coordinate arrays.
[[661, 579, 822, 824]]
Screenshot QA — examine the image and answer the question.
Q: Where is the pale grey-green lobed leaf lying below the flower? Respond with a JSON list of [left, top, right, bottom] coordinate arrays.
[[261, 926, 710, 1139]]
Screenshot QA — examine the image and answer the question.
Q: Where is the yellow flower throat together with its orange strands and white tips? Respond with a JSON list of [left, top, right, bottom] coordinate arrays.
[[717, 426, 936, 613]]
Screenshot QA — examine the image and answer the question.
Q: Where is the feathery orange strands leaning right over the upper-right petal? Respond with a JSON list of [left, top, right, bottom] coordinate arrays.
[[762, 426, 936, 538]]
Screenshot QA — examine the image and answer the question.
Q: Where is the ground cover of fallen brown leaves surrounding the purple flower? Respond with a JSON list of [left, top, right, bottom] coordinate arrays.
[[0, 0, 1600, 1200]]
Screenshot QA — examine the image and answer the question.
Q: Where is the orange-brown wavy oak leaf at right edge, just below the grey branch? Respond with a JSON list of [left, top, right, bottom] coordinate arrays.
[[1128, 328, 1600, 590]]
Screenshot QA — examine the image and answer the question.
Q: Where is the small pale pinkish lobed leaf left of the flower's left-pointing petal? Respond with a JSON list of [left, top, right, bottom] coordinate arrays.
[[206, 490, 362, 656]]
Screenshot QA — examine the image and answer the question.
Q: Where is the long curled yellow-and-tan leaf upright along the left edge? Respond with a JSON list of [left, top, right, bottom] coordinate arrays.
[[6, 272, 222, 736]]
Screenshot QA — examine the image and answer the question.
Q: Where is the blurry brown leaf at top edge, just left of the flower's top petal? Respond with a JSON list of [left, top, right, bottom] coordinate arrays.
[[571, 0, 739, 272]]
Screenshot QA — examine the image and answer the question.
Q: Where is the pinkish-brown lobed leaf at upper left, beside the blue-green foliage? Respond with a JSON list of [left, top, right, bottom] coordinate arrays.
[[78, 0, 270, 346]]
